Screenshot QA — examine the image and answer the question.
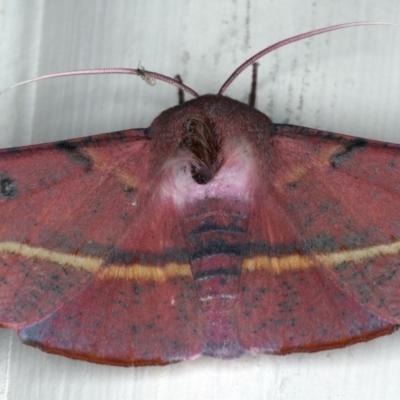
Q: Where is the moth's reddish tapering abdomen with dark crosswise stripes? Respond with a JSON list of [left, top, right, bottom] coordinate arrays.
[[183, 199, 248, 358]]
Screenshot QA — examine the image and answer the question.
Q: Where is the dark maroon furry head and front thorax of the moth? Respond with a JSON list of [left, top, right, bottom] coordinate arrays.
[[150, 95, 271, 185]]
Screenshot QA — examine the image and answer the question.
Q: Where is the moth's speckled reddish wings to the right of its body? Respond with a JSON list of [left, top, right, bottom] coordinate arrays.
[[236, 125, 400, 353]]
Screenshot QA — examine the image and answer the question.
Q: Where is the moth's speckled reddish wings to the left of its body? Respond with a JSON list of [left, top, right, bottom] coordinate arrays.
[[0, 130, 205, 365]]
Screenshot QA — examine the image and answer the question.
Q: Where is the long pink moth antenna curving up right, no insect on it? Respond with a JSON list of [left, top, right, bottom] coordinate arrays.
[[218, 21, 400, 94]]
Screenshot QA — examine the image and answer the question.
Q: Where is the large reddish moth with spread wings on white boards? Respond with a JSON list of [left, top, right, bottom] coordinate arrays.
[[0, 23, 400, 366]]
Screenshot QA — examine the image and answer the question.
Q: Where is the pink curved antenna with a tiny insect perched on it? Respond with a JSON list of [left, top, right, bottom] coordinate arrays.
[[0, 67, 199, 97]]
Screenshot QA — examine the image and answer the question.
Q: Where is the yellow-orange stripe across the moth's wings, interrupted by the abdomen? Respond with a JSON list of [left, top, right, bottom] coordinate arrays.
[[0, 242, 400, 282]]
